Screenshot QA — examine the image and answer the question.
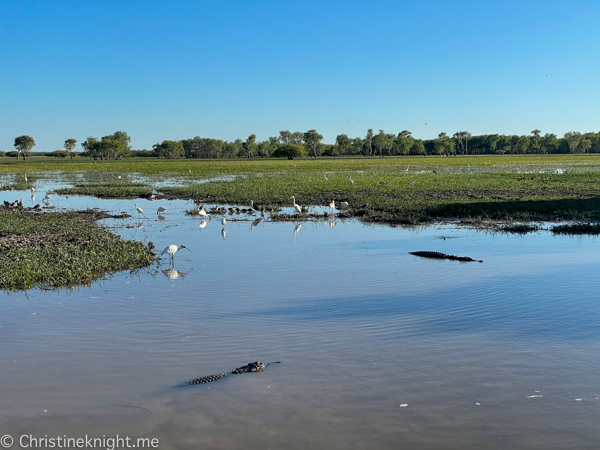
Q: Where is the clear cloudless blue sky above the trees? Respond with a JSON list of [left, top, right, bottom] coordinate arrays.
[[0, 0, 600, 151]]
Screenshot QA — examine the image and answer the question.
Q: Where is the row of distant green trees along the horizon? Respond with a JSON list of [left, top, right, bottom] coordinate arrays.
[[8, 129, 600, 160]]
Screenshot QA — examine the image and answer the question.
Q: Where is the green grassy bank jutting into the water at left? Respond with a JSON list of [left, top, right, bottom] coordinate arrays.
[[0, 209, 154, 291]]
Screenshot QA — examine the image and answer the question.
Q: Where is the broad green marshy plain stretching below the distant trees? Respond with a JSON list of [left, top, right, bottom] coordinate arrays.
[[0, 155, 600, 224]]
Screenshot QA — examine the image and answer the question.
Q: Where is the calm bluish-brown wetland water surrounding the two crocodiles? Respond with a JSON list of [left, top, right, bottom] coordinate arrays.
[[0, 191, 600, 450]]
